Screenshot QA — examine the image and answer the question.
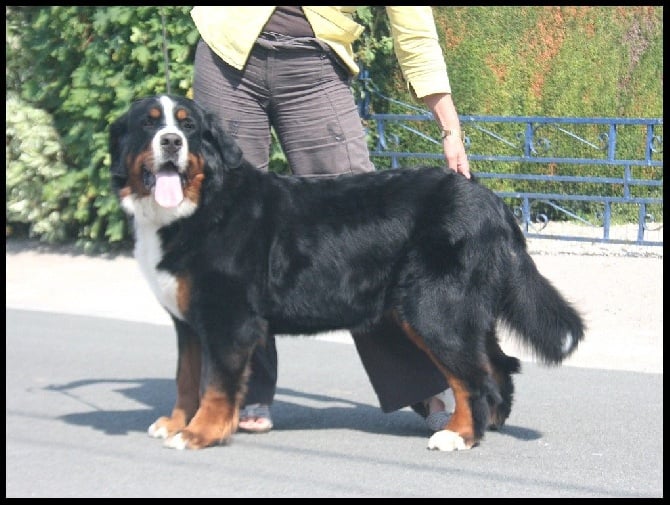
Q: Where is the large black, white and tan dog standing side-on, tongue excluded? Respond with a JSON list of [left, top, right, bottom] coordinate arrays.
[[110, 97, 584, 450]]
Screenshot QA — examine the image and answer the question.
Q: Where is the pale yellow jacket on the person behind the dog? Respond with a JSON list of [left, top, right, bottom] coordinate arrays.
[[191, 5, 451, 98]]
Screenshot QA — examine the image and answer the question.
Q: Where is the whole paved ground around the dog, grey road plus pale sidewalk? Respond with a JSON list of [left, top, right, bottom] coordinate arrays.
[[6, 243, 663, 498]]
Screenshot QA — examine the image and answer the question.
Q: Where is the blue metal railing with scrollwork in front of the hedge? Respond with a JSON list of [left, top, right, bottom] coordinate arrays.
[[358, 72, 663, 246]]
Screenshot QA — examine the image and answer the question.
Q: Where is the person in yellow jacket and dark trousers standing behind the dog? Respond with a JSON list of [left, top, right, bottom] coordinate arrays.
[[191, 6, 470, 433]]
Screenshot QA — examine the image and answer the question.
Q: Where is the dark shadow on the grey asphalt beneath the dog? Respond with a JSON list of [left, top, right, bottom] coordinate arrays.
[[44, 378, 541, 440]]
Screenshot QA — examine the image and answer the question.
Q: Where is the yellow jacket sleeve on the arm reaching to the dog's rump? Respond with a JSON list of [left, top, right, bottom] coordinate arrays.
[[386, 6, 451, 98]]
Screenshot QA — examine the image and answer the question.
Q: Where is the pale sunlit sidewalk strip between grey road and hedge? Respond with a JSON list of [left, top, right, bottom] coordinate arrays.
[[5, 239, 663, 373]]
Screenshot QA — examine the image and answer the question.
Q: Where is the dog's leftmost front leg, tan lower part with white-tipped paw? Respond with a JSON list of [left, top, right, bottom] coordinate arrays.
[[148, 319, 202, 438]]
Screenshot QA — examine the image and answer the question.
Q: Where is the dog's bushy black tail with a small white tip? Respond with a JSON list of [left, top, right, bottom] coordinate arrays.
[[501, 248, 585, 364]]
